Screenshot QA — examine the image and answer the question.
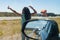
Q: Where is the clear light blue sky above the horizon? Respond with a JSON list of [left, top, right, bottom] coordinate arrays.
[[0, 0, 60, 14]]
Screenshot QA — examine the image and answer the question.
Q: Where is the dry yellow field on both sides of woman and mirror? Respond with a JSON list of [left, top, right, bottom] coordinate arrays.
[[0, 18, 60, 40]]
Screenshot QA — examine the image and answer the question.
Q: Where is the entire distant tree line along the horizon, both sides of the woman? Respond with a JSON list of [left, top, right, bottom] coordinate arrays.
[[0, 12, 60, 17]]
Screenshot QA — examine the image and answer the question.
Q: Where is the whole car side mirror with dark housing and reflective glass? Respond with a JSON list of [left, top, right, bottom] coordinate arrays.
[[24, 20, 59, 40]]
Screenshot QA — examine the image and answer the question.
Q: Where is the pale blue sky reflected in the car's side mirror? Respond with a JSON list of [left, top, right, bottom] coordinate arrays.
[[26, 20, 47, 29]]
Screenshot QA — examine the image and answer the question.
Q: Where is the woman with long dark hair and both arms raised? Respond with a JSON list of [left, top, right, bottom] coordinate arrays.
[[8, 6, 37, 40]]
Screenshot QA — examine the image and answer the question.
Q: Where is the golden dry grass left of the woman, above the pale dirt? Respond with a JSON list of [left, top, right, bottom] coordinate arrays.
[[0, 19, 21, 36]]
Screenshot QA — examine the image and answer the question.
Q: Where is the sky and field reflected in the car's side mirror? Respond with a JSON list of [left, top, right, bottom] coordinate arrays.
[[25, 20, 48, 39]]
